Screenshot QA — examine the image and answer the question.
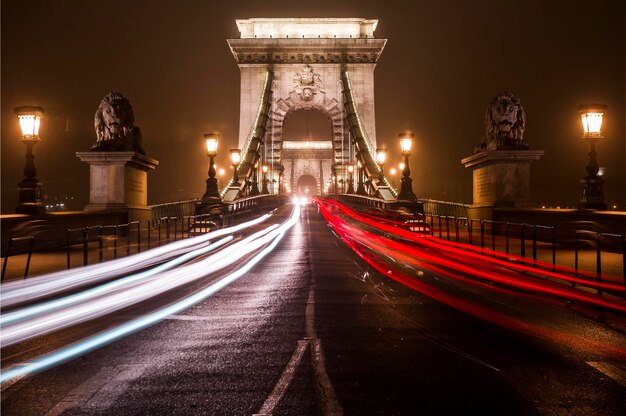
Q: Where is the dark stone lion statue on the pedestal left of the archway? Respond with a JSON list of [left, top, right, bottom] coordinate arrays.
[[91, 92, 146, 155]]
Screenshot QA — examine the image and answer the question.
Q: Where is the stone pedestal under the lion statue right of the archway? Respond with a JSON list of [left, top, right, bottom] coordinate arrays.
[[461, 150, 544, 219]]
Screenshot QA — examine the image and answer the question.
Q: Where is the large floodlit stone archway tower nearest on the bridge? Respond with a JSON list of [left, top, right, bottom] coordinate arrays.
[[228, 18, 386, 193]]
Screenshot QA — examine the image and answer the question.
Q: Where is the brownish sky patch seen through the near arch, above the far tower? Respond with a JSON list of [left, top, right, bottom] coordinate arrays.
[[282, 109, 333, 141]]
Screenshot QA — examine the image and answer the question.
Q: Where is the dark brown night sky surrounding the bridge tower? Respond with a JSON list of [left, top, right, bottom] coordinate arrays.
[[1, 0, 626, 213]]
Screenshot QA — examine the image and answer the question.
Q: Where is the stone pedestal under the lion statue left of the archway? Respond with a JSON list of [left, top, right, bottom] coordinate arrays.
[[76, 152, 159, 221]]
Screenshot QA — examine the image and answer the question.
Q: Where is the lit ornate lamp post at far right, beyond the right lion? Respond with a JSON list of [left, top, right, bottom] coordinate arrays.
[[578, 104, 607, 210]]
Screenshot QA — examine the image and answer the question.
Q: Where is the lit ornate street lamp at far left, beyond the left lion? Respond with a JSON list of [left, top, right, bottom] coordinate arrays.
[[14, 106, 46, 215]]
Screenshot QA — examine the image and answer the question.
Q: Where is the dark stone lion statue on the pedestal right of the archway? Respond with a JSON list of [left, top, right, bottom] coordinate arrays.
[[475, 91, 529, 153]]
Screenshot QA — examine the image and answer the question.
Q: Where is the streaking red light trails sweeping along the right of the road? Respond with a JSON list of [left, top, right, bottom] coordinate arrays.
[[314, 199, 626, 356]]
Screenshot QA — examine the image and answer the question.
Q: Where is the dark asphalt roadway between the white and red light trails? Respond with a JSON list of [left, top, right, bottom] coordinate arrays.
[[1, 206, 626, 415]]
